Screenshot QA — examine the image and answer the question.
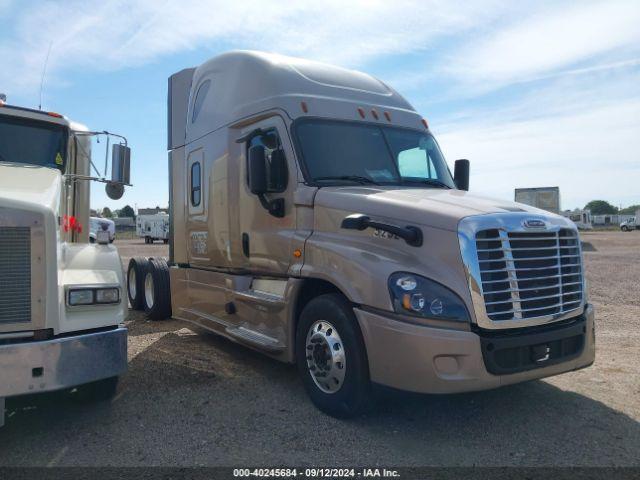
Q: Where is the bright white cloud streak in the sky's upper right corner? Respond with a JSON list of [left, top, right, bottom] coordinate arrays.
[[445, 0, 640, 90]]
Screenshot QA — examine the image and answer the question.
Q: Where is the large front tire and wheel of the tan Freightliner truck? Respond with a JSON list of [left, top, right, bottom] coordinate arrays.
[[296, 293, 371, 418]]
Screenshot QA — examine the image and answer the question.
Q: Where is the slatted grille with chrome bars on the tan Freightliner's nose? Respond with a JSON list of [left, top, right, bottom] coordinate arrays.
[[475, 228, 583, 321]]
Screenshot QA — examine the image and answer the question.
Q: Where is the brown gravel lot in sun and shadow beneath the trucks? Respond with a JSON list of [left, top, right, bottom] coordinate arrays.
[[0, 232, 640, 466]]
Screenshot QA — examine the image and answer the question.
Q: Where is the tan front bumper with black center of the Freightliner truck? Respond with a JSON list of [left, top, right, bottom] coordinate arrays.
[[355, 305, 595, 393]]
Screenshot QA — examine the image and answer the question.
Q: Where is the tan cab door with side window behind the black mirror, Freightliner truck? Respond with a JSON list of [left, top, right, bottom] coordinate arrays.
[[236, 116, 297, 275]]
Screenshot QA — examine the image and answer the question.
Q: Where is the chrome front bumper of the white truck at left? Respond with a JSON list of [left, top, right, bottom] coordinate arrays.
[[0, 328, 127, 398]]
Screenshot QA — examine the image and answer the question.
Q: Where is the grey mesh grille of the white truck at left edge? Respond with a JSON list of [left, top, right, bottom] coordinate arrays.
[[0, 227, 31, 324]]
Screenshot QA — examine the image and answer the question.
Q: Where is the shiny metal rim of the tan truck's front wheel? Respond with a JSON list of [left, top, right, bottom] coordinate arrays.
[[306, 320, 347, 393]]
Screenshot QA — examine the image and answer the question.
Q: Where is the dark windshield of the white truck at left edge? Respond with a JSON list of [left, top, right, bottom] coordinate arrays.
[[0, 115, 67, 173]]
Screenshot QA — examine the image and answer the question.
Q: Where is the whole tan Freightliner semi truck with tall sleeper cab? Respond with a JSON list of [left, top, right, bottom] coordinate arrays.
[[129, 52, 595, 416]]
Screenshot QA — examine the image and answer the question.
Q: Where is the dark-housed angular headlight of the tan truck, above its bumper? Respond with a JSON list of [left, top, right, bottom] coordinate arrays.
[[389, 272, 469, 322]]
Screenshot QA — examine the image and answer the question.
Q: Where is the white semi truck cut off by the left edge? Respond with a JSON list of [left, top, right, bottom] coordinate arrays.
[[0, 101, 130, 425]]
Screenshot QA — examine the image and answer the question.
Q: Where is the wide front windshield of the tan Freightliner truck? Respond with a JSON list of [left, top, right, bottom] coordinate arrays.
[[295, 120, 455, 188]]
